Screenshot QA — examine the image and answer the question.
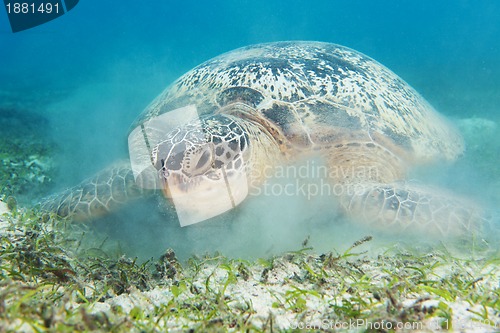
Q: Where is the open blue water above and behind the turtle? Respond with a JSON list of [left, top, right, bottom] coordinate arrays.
[[0, 0, 500, 258]]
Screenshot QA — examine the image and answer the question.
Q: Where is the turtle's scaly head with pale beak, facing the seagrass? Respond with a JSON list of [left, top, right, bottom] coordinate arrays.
[[152, 114, 249, 223]]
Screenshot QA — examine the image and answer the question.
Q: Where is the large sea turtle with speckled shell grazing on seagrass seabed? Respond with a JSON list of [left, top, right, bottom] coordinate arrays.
[[41, 41, 483, 236]]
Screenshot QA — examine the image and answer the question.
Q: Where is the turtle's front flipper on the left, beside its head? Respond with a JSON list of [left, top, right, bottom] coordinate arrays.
[[39, 162, 148, 221]]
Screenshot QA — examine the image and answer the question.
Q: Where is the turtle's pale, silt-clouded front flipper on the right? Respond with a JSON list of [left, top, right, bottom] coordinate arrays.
[[340, 182, 489, 237]]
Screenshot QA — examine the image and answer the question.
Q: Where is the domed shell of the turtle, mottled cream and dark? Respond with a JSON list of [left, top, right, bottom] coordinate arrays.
[[134, 41, 464, 161]]
